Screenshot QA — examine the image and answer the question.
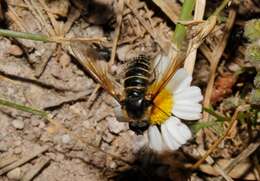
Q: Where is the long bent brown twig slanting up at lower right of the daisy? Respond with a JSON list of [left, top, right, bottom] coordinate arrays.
[[192, 105, 249, 169]]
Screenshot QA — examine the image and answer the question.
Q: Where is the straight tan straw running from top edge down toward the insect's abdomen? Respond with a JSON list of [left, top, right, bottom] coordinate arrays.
[[109, 0, 125, 67]]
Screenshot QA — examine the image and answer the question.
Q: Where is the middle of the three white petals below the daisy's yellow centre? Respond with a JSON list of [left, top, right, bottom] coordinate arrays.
[[161, 120, 181, 150]]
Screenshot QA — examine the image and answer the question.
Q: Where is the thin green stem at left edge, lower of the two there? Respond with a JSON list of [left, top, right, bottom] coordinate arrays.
[[0, 98, 48, 118]]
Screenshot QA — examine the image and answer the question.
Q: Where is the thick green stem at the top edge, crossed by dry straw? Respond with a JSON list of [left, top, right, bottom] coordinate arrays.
[[173, 0, 195, 49]]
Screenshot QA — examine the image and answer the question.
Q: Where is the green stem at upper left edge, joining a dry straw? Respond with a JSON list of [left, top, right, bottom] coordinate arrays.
[[0, 29, 50, 42]]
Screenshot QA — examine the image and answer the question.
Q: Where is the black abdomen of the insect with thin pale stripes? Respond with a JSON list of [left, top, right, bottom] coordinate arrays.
[[124, 55, 151, 97]]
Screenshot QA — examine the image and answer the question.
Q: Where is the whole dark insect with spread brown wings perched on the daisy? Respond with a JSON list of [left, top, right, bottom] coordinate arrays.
[[70, 44, 182, 134]]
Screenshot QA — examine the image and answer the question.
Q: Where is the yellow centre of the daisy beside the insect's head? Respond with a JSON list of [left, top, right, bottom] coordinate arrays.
[[150, 88, 174, 124]]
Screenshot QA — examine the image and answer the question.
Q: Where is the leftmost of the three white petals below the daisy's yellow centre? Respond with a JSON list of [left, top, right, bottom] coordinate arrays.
[[148, 125, 164, 152]]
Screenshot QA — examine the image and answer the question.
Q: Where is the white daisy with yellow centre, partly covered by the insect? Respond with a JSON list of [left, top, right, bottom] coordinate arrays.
[[148, 57, 203, 152]]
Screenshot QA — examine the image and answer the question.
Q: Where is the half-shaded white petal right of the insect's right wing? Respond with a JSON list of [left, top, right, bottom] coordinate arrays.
[[167, 68, 192, 93]]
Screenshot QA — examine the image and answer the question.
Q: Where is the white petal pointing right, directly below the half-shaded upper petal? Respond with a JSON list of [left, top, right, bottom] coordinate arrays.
[[174, 86, 203, 102]]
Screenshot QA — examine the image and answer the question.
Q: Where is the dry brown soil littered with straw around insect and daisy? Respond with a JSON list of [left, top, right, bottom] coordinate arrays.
[[0, 0, 260, 181]]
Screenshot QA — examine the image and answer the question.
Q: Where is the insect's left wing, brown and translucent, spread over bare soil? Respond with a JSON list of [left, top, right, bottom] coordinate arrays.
[[69, 43, 122, 102]]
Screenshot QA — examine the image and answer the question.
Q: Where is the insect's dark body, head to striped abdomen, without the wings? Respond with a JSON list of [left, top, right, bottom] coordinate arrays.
[[121, 55, 151, 134]]
